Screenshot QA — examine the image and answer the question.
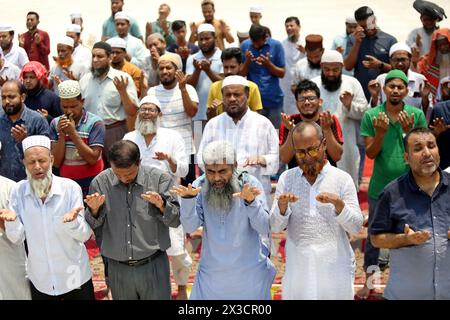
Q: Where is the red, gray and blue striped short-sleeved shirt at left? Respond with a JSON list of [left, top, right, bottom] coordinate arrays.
[[50, 110, 105, 184]]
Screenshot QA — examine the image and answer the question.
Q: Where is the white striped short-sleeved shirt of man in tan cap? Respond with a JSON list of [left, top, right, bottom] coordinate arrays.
[[148, 84, 198, 155]]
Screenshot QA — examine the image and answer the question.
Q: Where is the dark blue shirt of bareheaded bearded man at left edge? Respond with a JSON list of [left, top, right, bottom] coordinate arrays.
[[0, 106, 50, 182]]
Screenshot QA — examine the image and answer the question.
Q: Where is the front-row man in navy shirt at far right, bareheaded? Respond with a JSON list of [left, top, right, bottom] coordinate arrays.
[[369, 128, 450, 300]]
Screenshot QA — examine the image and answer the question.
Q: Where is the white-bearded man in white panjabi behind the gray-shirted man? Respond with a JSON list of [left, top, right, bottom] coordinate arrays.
[[123, 95, 192, 300]]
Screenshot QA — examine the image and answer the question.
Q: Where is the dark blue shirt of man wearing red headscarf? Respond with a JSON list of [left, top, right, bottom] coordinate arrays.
[[25, 88, 62, 123]]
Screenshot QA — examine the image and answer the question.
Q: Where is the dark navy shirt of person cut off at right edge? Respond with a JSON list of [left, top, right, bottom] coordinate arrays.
[[430, 101, 450, 170]]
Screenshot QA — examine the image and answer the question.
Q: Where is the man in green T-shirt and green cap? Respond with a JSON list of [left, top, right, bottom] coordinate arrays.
[[357, 69, 427, 299]]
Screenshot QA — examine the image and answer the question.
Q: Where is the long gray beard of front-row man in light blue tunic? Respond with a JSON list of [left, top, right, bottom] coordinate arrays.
[[203, 170, 241, 211]]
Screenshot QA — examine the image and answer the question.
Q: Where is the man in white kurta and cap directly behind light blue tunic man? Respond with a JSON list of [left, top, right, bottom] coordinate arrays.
[[197, 76, 279, 201]]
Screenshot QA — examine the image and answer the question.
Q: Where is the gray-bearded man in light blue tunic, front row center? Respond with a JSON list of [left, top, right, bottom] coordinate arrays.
[[172, 140, 276, 300]]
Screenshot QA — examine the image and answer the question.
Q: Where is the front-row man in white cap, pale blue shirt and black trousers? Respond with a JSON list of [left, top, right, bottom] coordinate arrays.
[[4, 136, 94, 300]]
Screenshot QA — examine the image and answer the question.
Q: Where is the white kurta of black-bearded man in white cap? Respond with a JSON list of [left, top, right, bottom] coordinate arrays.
[[312, 75, 369, 186]]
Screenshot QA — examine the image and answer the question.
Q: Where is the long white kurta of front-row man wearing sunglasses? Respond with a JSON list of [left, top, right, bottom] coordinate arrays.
[[270, 163, 364, 300]]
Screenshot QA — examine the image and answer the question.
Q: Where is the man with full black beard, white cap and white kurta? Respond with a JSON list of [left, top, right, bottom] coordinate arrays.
[[312, 50, 369, 187]]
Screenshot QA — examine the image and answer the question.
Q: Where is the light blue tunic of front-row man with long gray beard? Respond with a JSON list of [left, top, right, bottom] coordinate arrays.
[[180, 175, 276, 300]]
